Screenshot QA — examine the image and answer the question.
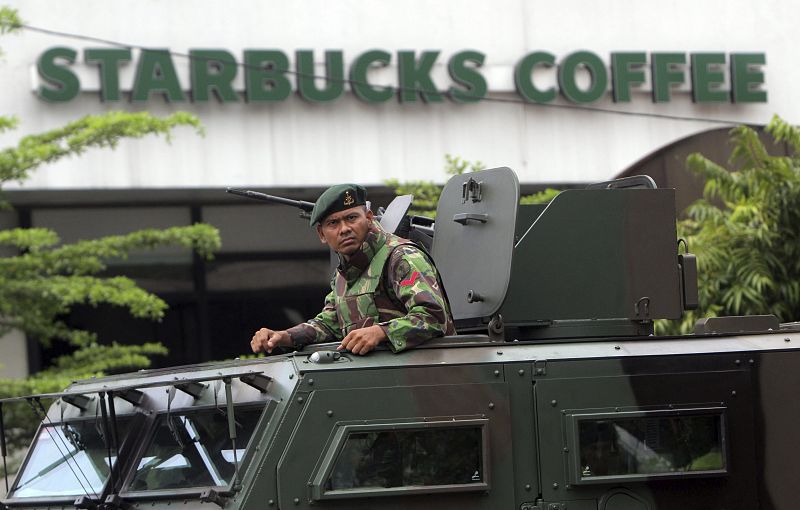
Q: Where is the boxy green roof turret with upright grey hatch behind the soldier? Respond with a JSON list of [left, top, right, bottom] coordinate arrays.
[[433, 168, 691, 339]]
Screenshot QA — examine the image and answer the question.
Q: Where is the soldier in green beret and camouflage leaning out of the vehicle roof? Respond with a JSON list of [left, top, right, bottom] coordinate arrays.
[[250, 184, 455, 354]]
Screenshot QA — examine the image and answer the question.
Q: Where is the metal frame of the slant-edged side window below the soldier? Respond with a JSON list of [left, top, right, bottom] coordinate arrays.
[[309, 416, 491, 501]]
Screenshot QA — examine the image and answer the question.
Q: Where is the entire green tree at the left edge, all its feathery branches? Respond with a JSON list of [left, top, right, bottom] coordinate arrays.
[[0, 7, 220, 467]]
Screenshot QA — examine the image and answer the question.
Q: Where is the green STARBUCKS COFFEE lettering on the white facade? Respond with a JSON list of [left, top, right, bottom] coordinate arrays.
[[36, 46, 767, 104]]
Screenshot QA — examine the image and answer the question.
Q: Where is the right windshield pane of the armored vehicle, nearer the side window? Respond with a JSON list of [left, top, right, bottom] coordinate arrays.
[[127, 407, 263, 492]]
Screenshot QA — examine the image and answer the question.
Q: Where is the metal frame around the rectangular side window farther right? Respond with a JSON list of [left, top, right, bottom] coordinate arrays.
[[565, 405, 730, 485]]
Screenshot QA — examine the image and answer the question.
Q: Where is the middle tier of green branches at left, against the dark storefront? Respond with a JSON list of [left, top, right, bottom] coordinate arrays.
[[0, 224, 219, 346]]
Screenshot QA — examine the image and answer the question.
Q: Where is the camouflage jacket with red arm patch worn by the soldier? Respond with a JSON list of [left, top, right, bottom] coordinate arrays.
[[287, 222, 455, 352]]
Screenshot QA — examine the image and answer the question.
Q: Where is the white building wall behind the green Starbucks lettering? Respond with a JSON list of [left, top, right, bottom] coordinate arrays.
[[0, 0, 800, 189]]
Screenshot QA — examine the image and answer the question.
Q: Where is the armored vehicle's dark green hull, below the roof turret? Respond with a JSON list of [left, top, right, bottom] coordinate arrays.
[[3, 330, 800, 510]]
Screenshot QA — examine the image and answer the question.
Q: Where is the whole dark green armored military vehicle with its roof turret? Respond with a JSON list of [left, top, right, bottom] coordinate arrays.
[[0, 168, 800, 510]]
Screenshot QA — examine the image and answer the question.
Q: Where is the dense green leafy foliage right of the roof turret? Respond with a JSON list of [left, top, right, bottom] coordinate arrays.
[[657, 116, 800, 333]]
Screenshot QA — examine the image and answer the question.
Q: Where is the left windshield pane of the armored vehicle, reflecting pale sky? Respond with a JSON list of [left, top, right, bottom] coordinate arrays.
[[9, 420, 127, 498]]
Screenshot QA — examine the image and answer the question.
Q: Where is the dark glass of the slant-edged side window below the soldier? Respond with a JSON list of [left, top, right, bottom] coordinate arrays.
[[325, 427, 485, 490]]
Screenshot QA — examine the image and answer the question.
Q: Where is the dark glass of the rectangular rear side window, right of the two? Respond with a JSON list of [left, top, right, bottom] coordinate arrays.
[[578, 414, 725, 480]]
